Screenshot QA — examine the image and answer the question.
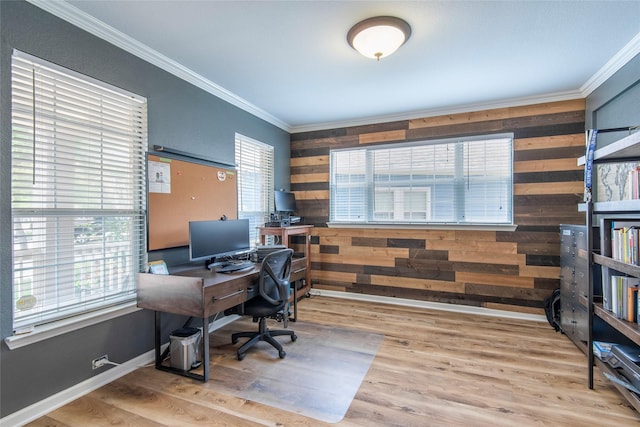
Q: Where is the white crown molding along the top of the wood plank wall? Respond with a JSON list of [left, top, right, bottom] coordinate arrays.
[[289, 90, 583, 134]]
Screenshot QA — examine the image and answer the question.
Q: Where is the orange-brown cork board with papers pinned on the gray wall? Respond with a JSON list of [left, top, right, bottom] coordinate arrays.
[[147, 155, 238, 251]]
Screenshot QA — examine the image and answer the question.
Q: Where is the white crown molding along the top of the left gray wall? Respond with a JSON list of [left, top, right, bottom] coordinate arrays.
[[27, 0, 290, 132]]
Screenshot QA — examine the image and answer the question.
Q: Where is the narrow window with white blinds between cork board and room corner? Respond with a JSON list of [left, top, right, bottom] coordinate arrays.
[[236, 134, 274, 247]]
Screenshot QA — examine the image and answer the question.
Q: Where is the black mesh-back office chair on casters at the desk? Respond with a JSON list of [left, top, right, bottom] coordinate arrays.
[[231, 249, 298, 360]]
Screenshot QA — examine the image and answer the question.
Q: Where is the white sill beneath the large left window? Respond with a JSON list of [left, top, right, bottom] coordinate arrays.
[[4, 301, 142, 350]]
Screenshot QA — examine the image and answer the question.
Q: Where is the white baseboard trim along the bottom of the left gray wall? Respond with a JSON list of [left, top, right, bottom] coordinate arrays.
[[0, 315, 240, 427]]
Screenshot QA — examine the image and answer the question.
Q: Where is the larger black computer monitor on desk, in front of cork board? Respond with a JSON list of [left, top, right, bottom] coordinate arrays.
[[189, 219, 251, 263]]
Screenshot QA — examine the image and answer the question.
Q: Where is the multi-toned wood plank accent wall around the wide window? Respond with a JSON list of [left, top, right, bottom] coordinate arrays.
[[291, 99, 585, 313]]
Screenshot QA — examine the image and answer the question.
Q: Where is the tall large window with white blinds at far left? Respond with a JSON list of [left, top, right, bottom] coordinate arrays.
[[11, 51, 147, 330]]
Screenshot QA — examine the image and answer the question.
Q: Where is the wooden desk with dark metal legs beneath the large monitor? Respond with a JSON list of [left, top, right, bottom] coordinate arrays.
[[138, 259, 305, 382]]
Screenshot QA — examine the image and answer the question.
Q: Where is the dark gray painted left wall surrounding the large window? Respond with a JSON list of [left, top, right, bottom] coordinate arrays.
[[0, 1, 290, 417]]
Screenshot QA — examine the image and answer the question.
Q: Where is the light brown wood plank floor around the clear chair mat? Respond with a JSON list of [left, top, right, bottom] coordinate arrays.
[[29, 296, 640, 427]]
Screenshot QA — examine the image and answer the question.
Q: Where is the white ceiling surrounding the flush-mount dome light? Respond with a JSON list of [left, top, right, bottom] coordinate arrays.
[[30, 0, 640, 132]]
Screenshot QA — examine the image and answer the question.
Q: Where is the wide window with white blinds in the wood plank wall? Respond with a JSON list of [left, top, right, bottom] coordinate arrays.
[[330, 135, 513, 225]]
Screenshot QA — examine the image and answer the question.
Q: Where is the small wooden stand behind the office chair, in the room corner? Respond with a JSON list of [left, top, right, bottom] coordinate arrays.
[[259, 225, 313, 314]]
